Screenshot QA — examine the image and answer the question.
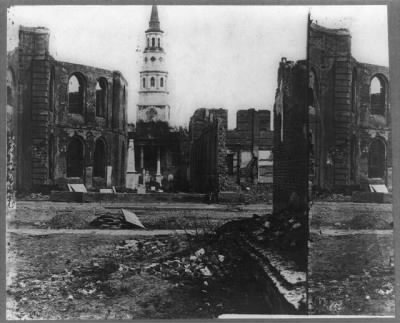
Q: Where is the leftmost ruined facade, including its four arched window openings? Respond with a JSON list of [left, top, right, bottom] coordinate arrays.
[[7, 27, 127, 191]]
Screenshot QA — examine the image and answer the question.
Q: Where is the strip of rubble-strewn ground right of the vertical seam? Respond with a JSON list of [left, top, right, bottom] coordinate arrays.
[[309, 202, 395, 315]]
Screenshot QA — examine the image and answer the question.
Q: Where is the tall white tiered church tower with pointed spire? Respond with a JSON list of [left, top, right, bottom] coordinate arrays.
[[136, 5, 170, 122]]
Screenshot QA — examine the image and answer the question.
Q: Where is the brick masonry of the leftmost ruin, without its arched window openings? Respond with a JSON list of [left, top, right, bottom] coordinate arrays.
[[9, 27, 127, 191]]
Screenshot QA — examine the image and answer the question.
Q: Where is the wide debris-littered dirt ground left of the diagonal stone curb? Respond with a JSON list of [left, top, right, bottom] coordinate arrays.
[[7, 202, 274, 319]]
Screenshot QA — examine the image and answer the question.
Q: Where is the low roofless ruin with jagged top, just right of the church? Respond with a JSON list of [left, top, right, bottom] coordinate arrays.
[[189, 108, 272, 192]]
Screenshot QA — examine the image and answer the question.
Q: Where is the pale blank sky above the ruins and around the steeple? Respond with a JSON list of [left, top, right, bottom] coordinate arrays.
[[7, 5, 388, 128]]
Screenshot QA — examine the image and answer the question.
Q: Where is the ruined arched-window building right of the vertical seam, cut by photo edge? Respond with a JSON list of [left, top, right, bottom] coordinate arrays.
[[308, 24, 392, 191]]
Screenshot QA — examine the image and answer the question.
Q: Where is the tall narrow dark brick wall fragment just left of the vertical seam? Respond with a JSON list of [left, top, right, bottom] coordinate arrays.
[[273, 59, 308, 212]]
